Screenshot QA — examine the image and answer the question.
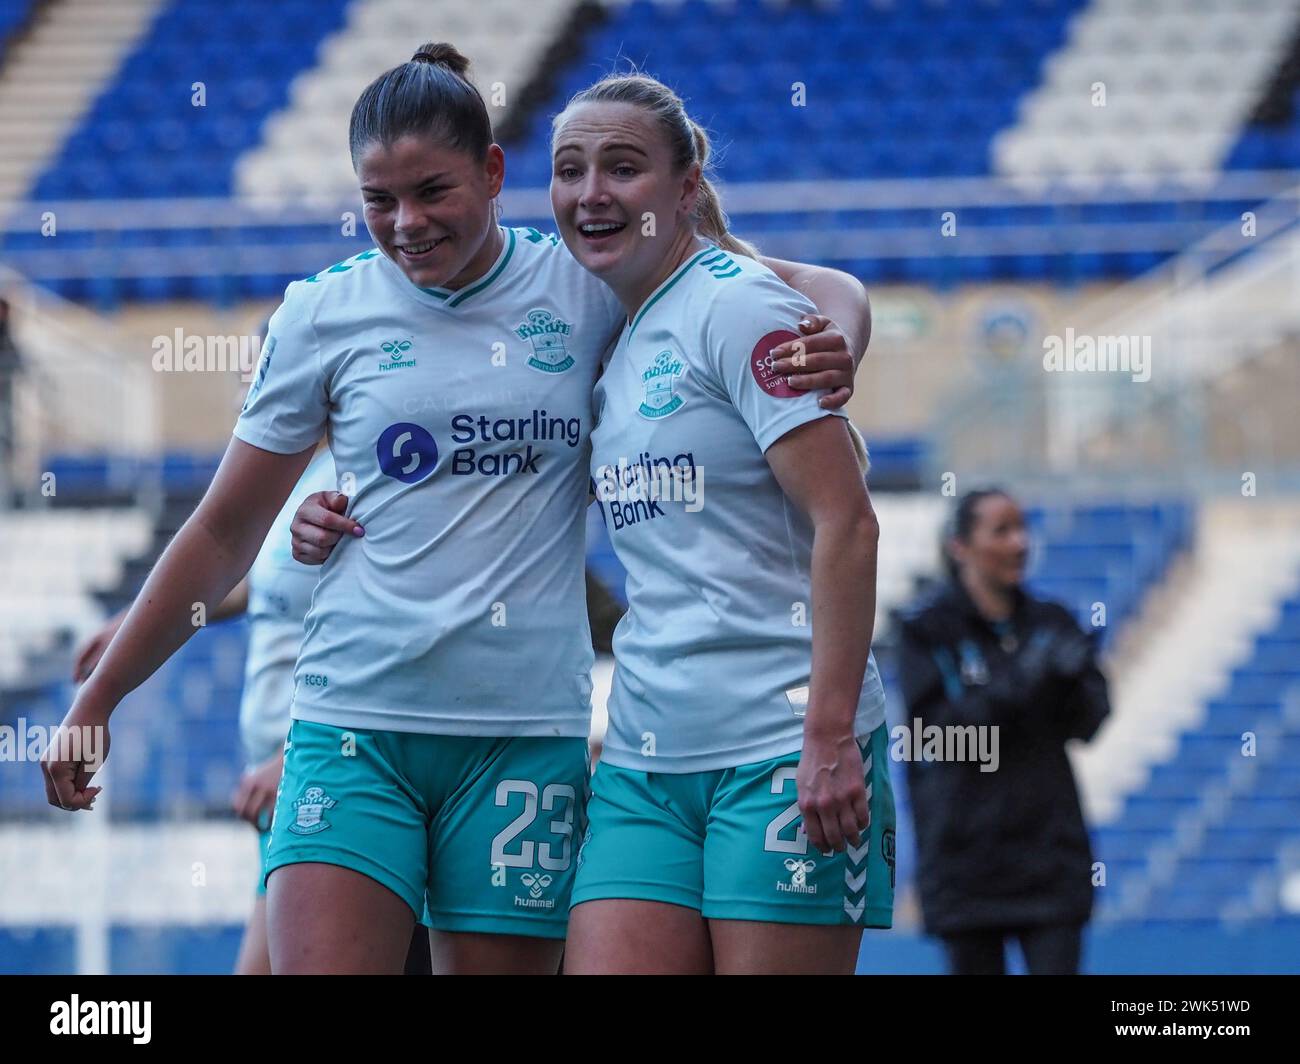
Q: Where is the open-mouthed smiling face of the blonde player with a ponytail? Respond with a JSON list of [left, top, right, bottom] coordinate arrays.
[[551, 103, 699, 295]]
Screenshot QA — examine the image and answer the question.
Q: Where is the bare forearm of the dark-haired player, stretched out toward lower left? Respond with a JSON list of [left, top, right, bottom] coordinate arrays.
[[77, 514, 256, 718]]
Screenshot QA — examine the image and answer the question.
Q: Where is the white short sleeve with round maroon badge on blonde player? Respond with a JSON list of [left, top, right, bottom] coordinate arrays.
[[703, 273, 844, 451]]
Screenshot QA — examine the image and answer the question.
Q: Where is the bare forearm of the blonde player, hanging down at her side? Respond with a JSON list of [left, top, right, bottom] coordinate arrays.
[[805, 509, 880, 736]]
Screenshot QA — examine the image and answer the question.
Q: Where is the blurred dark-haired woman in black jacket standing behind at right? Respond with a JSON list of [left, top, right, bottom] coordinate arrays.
[[898, 488, 1110, 974]]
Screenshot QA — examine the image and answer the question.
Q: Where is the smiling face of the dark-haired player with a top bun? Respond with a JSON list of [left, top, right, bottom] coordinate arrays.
[[356, 135, 506, 289]]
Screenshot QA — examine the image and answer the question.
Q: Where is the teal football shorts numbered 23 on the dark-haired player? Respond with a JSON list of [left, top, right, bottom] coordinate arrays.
[[264, 721, 590, 939]]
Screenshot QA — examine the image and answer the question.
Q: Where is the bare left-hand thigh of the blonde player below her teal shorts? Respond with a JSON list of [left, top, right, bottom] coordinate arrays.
[[564, 898, 714, 976]]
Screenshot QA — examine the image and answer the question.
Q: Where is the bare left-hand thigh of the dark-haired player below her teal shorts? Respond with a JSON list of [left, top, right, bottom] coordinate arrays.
[[267, 862, 415, 976]]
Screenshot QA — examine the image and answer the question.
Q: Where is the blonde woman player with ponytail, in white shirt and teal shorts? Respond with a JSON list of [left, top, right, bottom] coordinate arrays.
[[551, 74, 894, 974]]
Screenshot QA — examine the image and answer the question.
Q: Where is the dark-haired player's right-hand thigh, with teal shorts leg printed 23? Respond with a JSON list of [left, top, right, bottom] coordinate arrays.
[[428, 736, 588, 957]]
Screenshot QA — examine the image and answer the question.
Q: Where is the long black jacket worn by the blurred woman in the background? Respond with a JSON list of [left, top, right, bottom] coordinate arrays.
[[898, 581, 1110, 934]]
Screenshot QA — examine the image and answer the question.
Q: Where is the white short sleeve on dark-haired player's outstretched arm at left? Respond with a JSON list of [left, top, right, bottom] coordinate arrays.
[[234, 282, 329, 454]]
